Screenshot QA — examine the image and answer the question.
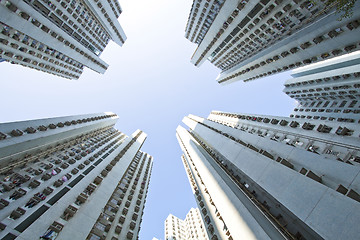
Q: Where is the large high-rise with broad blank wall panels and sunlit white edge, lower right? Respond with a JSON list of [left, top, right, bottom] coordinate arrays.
[[176, 111, 360, 240]]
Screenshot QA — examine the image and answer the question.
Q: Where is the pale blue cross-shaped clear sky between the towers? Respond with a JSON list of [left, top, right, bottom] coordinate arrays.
[[0, 0, 294, 240]]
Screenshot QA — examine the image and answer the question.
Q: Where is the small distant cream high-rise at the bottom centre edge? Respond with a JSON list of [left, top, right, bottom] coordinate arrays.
[[165, 208, 209, 240]]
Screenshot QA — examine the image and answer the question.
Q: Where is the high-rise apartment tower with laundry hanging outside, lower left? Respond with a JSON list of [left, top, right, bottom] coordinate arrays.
[[0, 113, 153, 240]]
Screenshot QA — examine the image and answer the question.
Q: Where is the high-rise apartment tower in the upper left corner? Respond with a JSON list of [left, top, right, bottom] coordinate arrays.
[[0, 0, 126, 79]]
